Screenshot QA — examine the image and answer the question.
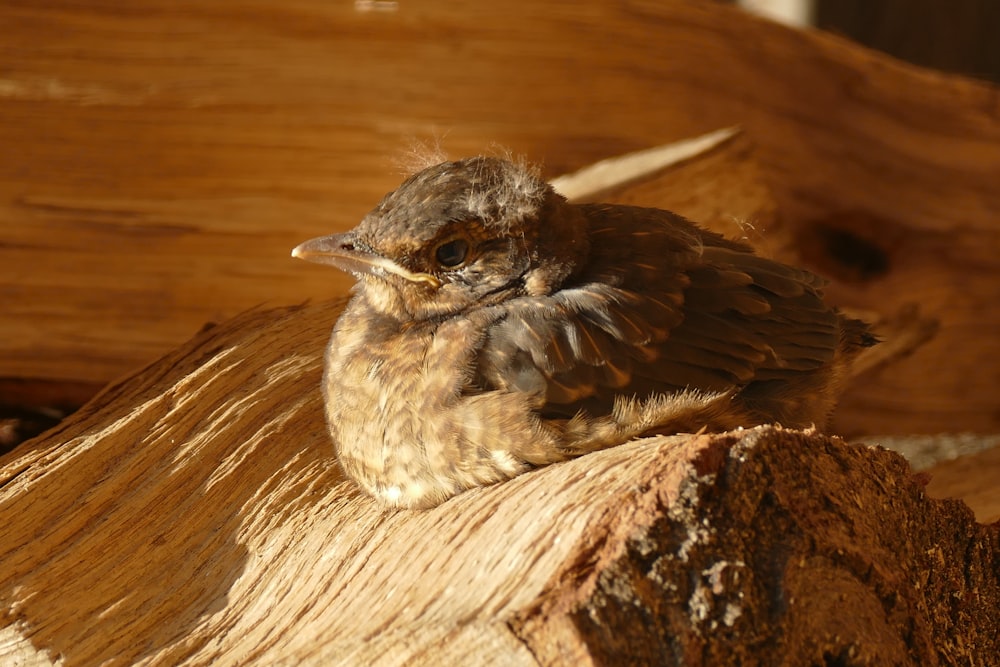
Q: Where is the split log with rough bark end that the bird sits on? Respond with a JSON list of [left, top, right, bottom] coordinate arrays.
[[0, 303, 1000, 665]]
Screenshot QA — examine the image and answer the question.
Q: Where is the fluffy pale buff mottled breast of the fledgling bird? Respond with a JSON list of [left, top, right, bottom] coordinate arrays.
[[324, 300, 523, 507]]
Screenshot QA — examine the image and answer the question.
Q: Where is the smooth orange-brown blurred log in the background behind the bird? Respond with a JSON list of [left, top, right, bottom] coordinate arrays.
[[0, 0, 1000, 433]]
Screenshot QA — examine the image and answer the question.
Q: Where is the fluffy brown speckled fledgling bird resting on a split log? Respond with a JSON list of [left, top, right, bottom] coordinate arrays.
[[292, 155, 877, 509]]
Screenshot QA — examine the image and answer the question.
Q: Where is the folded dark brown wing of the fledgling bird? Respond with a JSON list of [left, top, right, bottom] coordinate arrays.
[[477, 246, 838, 407]]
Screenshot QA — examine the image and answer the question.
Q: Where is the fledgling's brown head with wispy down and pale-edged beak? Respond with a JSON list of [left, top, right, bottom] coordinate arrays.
[[292, 157, 589, 320]]
